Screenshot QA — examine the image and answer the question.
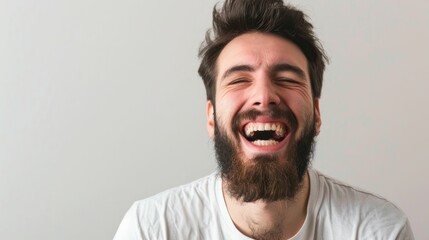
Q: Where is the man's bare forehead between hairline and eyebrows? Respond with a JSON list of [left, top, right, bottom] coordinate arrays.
[[216, 32, 309, 79]]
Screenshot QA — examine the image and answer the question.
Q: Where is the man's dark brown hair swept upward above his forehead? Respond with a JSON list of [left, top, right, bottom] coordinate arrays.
[[198, 0, 327, 104]]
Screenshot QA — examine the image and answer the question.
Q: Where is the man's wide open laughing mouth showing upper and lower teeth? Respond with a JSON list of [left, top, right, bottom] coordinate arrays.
[[243, 122, 287, 146]]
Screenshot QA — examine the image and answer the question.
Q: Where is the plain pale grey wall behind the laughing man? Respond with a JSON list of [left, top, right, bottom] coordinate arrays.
[[0, 0, 429, 240]]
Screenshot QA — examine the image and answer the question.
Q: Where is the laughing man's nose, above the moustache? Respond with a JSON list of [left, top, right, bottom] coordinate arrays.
[[250, 78, 280, 108]]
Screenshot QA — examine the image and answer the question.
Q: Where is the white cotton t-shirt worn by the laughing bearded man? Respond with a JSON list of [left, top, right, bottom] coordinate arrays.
[[114, 168, 414, 240]]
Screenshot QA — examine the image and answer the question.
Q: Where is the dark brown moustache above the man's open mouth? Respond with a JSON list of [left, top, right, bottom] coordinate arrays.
[[232, 106, 298, 133]]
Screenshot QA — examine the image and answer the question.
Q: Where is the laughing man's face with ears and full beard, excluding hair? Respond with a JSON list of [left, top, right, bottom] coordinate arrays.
[[207, 33, 320, 201]]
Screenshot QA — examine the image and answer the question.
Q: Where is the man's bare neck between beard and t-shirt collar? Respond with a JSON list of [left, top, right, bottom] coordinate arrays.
[[223, 172, 310, 239]]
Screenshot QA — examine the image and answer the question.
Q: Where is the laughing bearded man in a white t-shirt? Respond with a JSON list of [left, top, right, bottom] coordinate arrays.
[[115, 0, 413, 240]]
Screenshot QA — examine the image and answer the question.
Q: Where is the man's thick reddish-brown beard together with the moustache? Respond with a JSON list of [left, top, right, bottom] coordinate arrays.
[[214, 108, 315, 202]]
